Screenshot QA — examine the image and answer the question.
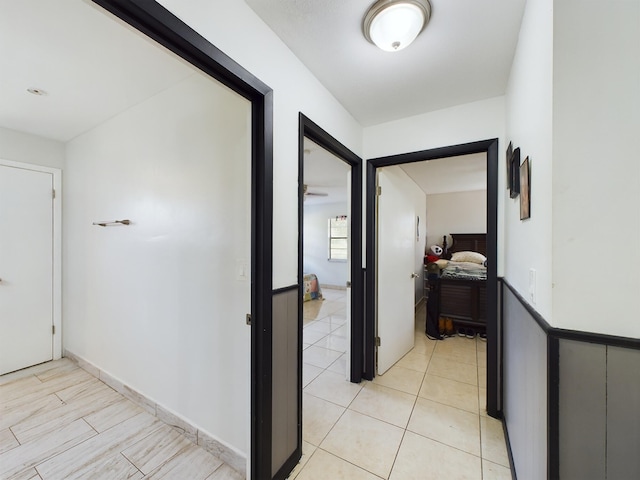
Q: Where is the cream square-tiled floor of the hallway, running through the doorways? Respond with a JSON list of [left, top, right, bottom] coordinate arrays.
[[289, 288, 511, 480]]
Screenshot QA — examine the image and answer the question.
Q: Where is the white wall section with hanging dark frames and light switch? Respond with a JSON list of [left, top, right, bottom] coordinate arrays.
[[500, 0, 555, 324]]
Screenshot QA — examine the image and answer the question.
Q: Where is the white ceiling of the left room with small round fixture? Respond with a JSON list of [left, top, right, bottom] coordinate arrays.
[[0, 0, 196, 142]]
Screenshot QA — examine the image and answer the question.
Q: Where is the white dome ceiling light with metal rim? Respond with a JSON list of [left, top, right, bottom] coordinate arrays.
[[362, 0, 431, 52]]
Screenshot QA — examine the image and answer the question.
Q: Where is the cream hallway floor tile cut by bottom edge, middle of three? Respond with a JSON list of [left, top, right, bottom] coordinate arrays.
[[389, 432, 482, 480]]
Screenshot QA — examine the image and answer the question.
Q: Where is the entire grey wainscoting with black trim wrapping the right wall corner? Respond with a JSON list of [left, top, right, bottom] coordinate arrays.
[[501, 279, 640, 480]]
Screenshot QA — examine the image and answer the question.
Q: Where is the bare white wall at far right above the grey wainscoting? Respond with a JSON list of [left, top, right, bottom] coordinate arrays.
[[552, 0, 640, 338]]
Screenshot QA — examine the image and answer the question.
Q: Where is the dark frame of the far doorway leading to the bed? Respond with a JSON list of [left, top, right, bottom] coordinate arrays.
[[363, 138, 502, 417]]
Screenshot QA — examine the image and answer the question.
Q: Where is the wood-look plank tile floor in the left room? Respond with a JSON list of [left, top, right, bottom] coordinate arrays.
[[0, 359, 243, 480]]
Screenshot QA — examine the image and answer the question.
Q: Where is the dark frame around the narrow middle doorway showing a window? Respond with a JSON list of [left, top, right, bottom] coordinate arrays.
[[298, 113, 364, 382]]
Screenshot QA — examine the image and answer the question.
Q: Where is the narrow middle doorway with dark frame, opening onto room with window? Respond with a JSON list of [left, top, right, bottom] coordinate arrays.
[[298, 114, 364, 384]]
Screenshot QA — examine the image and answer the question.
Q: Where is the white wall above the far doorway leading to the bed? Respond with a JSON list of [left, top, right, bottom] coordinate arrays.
[[364, 97, 506, 275]]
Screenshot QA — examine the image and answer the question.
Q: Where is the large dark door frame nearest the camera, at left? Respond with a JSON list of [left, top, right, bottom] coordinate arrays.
[[93, 0, 276, 480]]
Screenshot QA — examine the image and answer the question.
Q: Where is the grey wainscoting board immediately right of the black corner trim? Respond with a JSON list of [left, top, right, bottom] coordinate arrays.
[[558, 339, 614, 480]]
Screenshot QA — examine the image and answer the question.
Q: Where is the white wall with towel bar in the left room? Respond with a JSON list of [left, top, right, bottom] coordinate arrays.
[[63, 73, 251, 454]]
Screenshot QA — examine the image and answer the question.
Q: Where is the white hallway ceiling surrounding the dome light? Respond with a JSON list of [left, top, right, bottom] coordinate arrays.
[[245, 0, 526, 126]]
